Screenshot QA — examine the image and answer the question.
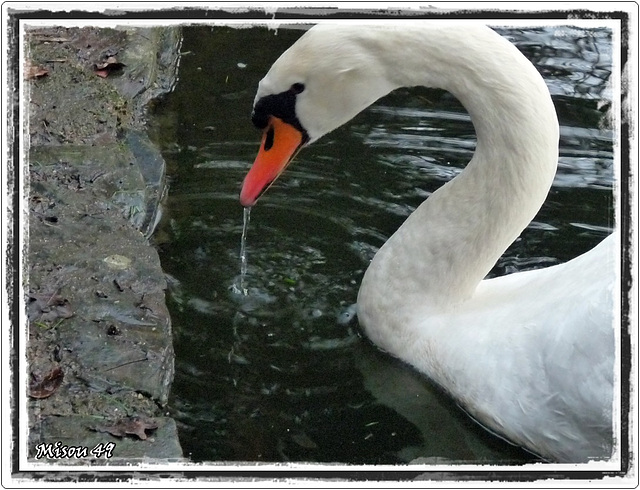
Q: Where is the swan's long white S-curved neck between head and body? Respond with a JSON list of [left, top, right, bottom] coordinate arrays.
[[358, 27, 558, 336]]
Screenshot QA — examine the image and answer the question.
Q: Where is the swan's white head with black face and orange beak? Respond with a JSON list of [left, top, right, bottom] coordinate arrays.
[[240, 26, 395, 207]]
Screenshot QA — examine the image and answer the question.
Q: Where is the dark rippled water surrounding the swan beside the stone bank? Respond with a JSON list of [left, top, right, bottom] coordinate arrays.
[[153, 27, 613, 464]]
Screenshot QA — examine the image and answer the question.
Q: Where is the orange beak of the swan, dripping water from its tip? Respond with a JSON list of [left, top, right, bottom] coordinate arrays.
[[240, 116, 304, 207]]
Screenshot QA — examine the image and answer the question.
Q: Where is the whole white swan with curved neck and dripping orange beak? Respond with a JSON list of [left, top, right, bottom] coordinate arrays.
[[240, 21, 615, 462]]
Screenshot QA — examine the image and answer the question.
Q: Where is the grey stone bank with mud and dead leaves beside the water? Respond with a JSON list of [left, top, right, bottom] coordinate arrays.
[[23, 23, 182, 464]]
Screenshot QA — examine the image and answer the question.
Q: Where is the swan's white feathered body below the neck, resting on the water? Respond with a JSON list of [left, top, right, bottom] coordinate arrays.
[[394, 235, 615, 462]]
